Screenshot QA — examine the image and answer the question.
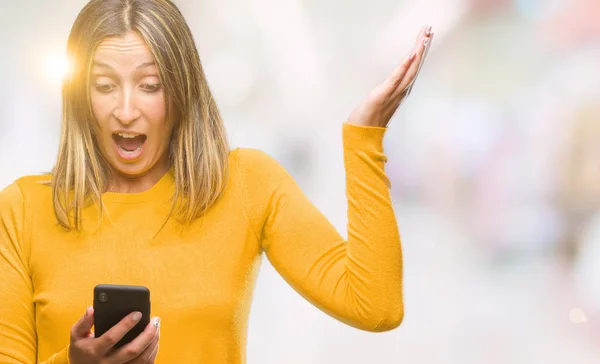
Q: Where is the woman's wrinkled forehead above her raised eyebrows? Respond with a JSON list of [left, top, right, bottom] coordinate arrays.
[[94, 32, 154, 68]]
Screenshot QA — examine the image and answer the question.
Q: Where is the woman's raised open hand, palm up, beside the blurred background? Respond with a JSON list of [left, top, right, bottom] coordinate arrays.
[[348, 26, 433, 127]]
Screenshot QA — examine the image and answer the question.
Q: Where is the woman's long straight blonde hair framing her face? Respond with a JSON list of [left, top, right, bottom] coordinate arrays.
[[52, 0, 229, 231]]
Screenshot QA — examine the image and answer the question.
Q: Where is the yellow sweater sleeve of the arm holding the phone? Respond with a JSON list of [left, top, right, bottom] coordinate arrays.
[[0, 183, 68, 364]]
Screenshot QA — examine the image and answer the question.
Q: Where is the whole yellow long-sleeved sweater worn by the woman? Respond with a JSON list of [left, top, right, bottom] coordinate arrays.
[[0, 123, 403, 364]]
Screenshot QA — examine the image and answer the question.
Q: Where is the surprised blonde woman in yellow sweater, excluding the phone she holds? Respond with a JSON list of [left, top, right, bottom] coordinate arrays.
[[0, 0, 432, 364]]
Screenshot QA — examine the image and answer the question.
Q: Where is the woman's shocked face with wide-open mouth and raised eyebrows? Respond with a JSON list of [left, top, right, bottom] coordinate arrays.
[[90, 32, 173, 177]]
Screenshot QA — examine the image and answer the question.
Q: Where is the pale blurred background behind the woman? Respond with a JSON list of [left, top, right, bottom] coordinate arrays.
[[0, 0, 600, 364]]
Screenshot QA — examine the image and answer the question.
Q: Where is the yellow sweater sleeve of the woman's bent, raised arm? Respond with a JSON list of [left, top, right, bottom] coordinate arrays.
[[234, 123, 404, 332]]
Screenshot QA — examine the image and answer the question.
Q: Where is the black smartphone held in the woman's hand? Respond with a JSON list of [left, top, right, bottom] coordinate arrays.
[[94, 284, 150, 348]]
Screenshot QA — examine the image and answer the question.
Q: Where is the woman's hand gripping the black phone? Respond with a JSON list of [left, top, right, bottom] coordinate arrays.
[[69, 307, 160, 364]]
